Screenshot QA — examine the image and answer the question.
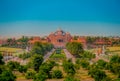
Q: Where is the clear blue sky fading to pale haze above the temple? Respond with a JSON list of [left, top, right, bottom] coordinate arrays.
[[0, 0, 120, 37]]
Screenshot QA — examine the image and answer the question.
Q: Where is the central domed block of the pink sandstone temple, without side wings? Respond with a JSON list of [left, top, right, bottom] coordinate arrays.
[[48, 29, 72, 48]]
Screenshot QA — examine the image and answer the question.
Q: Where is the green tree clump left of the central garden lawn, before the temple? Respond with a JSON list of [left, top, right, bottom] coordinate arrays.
[[31, 42, 53, 55]]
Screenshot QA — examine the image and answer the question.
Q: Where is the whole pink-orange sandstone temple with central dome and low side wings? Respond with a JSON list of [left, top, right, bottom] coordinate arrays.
[[29, 29, 86, 48]]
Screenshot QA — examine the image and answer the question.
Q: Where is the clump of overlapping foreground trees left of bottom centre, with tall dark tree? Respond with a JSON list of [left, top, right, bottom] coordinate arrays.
[[26, 54, 63, 81]]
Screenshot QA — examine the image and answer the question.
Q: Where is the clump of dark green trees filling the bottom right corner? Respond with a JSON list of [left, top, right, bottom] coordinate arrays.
[[88, 55, 120, 81]]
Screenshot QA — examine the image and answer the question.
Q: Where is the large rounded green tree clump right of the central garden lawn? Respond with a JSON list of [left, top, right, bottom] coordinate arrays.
[[66, 42, 84, 56]]
